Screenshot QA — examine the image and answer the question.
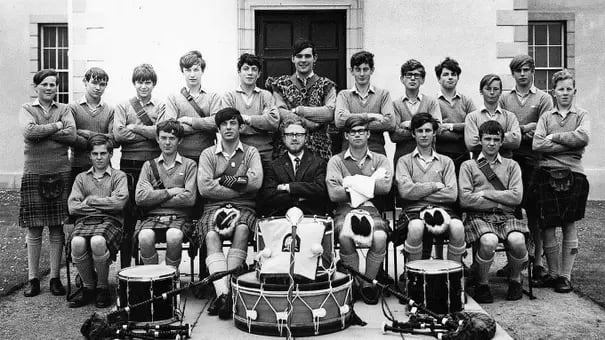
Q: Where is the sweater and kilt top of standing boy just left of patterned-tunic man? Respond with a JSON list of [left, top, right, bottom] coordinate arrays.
[[222, 87, 279, 153]]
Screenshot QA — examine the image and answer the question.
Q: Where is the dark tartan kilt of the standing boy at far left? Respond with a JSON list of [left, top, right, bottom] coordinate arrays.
[[19, 171, 72, 228]]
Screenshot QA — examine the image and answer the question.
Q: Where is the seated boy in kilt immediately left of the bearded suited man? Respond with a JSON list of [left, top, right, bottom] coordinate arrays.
[[197, 107, 263, 319]]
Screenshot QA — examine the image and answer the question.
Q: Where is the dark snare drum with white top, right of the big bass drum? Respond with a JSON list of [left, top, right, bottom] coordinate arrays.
[[405, 260, 464, 314]]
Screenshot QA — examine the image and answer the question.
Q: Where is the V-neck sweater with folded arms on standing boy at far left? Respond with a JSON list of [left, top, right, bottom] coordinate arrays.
[[19, 99, 76, 174]]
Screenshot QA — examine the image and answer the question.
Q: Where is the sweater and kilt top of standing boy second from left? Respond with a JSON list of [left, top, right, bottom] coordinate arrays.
[[69, 98, 114, 167]]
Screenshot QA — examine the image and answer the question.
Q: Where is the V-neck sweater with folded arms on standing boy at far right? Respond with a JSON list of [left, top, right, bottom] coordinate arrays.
[[533, 106, 590, 174]]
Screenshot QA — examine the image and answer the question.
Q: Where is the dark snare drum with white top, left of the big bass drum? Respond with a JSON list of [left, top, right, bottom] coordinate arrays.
[[117, 264, 180, 324]]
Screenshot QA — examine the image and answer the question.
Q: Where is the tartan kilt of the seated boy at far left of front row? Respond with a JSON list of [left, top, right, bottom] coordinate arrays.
[[71, 216, 122, 260]]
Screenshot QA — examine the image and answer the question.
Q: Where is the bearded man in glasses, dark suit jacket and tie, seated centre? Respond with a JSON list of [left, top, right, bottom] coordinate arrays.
[[258, 118, 331, 216]]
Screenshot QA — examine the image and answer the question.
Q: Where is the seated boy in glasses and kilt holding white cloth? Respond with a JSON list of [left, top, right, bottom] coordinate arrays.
[[326, 115, 393, 304]]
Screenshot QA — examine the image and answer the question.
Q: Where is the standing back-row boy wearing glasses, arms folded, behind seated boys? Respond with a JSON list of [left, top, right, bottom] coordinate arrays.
[[390, 59, 441, 164]]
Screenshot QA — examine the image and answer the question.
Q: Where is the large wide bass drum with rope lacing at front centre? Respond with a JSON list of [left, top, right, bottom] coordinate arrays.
[[231, 272, 353, 336]]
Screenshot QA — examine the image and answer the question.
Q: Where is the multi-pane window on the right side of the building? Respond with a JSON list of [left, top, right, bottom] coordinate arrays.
[[528, 21, 566, 90]]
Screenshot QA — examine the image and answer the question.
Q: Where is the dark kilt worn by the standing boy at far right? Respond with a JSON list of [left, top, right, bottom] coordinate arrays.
[[535, 168, 590, 229]]
